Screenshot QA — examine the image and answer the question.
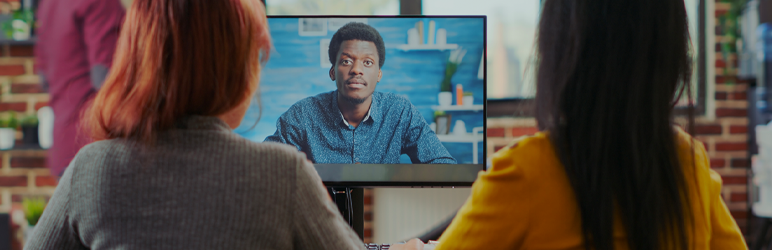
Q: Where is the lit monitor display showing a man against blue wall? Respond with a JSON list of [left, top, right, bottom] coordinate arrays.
[[235, 16, 485, 164]]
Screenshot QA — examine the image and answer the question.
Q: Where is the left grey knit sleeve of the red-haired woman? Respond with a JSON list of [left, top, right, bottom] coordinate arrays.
[[24, 160, 87, 250]]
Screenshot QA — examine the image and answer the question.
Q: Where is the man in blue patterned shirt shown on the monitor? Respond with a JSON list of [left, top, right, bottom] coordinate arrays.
[[265, 23, 456, 164]]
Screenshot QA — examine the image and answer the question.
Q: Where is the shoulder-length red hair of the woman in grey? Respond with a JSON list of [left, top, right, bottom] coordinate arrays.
[[83, 0, 271, 143]]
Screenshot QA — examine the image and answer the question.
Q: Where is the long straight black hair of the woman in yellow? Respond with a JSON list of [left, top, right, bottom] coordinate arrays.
[[536, 0, 694, 250]]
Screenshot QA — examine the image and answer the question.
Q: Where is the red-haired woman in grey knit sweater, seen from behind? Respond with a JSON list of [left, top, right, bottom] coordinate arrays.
[[26, 0, 364, 249]]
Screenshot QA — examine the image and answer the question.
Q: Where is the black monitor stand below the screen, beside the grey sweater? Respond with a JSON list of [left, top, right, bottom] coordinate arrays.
[[327, 186, 365, 240]]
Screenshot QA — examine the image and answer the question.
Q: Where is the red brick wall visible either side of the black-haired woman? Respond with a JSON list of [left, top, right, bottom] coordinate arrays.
[[487, 0, 750, 238]]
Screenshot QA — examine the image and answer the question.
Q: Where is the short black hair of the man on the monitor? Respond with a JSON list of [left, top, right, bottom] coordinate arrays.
[[327, 22, 386, 68]]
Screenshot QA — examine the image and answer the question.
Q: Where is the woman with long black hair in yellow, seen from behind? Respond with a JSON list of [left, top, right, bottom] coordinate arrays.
[[392, 0, 747, 250]]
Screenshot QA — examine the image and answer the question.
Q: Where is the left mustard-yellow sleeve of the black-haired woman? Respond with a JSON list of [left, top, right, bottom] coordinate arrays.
[[435, 141, 532, 250]]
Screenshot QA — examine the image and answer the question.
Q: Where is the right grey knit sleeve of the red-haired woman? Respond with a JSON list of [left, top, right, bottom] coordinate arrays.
[[292, 153, 364, 249]]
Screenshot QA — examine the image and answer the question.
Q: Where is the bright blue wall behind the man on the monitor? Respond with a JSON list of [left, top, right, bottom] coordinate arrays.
[[236, 18, 485, 163]]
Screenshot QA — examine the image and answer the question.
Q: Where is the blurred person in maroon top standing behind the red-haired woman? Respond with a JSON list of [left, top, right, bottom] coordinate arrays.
[[35, 0, 128, 176]]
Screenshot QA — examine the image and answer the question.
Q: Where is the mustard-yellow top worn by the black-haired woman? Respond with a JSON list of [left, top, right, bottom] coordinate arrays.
[[435, 128, 747, 250]]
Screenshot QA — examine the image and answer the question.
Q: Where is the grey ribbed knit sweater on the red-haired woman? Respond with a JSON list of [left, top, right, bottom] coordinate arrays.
[[25, 116, 364, 249]]
